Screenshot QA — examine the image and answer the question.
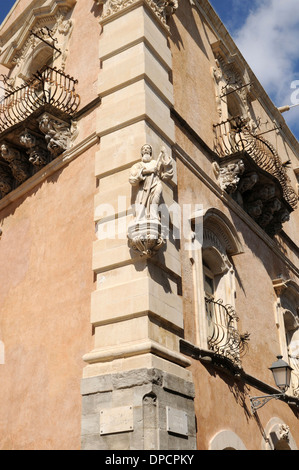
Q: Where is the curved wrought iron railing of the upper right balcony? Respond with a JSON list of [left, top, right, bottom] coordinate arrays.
[[214, 117, 298, 209]]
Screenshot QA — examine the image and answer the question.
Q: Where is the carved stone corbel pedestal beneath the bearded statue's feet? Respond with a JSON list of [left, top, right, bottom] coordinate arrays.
[[128, 219, 165, 258]]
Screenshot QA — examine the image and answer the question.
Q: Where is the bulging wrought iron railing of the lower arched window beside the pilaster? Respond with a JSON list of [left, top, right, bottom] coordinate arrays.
[[205, 297, 249, 367]]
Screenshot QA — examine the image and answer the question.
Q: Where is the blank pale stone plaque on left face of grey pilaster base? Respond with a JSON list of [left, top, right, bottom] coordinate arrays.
[[100, 406, 133, 435]]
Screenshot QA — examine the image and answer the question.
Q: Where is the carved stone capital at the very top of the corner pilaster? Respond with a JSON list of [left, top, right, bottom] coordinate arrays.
[[95, 0, 178, 24]]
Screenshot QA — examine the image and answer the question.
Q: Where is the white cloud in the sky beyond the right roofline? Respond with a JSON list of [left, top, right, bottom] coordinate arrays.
[[234, 0, 299, 106]]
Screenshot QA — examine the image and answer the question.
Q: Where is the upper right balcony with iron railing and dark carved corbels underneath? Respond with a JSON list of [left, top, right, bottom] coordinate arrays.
[[214, 118, 298, 237]]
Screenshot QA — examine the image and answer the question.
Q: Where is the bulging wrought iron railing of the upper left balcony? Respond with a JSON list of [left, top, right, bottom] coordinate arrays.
[[0, 67, 80, 133]]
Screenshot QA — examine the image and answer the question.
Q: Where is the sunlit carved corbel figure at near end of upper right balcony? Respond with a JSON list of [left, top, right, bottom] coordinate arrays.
[[213, 160, 245, 194]]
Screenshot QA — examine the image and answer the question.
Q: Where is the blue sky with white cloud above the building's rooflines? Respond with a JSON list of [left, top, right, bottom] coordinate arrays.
[[0, 0, 299, 140]]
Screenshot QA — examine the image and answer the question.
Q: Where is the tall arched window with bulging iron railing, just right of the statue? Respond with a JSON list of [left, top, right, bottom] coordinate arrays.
[[191, 208, 248, 365]]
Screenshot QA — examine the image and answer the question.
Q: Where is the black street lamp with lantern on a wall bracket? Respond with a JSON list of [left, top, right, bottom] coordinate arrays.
[[250, 356, 293, 413]]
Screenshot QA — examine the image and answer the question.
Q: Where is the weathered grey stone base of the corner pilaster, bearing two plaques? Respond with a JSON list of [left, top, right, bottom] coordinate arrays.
[[81, 369, 196, 450]]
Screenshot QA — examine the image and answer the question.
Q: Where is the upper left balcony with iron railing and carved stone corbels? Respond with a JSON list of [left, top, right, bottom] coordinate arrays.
[[0, 67, 80, 199]]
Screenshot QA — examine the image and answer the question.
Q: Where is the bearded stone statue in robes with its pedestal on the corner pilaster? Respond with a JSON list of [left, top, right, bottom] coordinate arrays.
[[128, 144, 173, 257]]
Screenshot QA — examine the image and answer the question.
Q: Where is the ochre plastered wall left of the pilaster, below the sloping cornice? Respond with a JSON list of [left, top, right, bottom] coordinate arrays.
[[0, 149, 95, 450]]
